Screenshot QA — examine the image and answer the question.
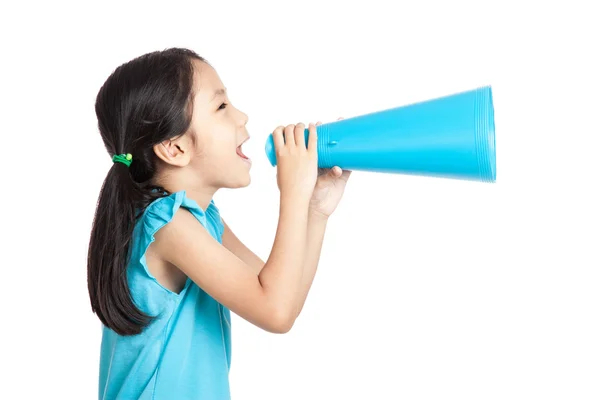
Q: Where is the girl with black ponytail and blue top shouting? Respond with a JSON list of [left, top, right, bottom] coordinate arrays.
[[88, 49, 350, 400]]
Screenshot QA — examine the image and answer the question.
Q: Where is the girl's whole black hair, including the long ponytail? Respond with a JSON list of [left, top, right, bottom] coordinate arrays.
[[87, 48, 206, 335]]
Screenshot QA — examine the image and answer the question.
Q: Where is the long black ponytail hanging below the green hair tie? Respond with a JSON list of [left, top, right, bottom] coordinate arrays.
[[87, 163, 162, 335]]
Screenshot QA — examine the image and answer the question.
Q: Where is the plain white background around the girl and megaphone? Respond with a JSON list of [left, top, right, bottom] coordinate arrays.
[[0, 0, 600, 400]]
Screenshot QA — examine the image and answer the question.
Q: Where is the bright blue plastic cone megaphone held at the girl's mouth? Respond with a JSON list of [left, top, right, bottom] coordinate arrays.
[[265, 86, 496, 182]]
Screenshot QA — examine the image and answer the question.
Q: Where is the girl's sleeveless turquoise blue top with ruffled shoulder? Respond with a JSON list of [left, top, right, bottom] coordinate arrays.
[[99, 191, 231, 400]]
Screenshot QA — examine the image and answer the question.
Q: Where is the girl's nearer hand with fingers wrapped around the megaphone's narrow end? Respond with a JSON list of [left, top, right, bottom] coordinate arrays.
[[273, 123, 318, 201]]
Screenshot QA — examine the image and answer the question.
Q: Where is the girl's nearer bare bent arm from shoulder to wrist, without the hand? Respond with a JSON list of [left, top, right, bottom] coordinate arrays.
[[154, 197, 308, 333]]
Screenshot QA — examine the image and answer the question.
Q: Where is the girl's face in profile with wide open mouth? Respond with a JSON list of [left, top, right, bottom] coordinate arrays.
[[180, 61, 251, 188]]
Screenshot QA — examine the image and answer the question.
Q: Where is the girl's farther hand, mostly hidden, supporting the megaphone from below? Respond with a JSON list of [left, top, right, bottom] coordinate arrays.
[[310, 118, 352, 218]]
